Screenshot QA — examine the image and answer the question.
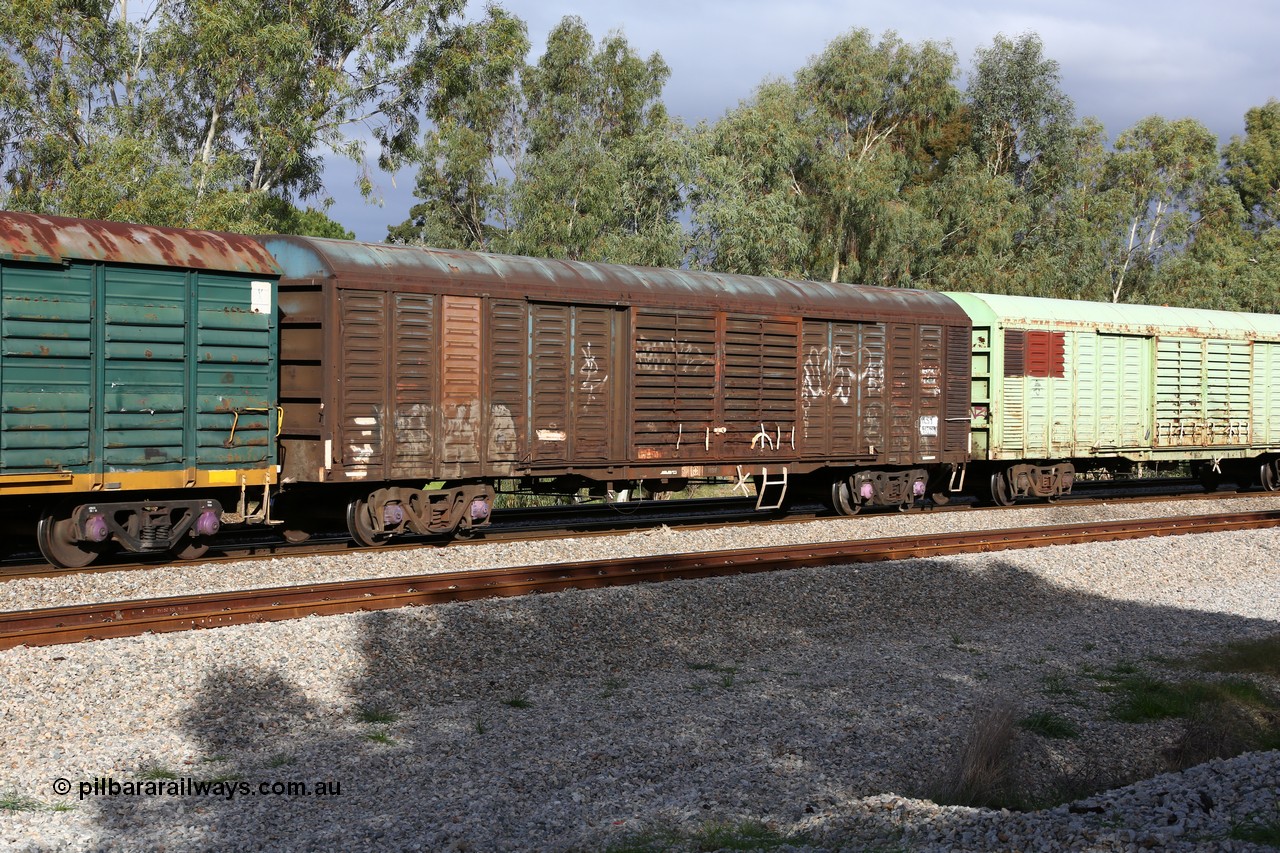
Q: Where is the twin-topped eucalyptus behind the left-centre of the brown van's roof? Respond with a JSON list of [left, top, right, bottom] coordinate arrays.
[[508, 18, 685, 265]]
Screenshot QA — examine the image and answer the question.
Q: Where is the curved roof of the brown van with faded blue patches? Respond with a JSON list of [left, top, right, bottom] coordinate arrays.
[[260, 236, 968, 325]]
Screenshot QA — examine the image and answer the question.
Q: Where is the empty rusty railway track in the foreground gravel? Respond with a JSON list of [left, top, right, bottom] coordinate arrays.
[[0, 502, 1280, 648]]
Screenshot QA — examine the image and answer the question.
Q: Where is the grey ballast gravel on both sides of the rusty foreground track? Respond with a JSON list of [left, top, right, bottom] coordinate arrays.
[[0, 498, 1280, 850]]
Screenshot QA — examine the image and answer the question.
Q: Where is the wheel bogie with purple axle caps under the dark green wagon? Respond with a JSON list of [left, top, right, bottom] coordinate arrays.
[[36, 498, 223, 569]]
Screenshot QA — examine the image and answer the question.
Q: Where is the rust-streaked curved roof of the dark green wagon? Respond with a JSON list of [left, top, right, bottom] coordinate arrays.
[[0, 211, 279, 272]]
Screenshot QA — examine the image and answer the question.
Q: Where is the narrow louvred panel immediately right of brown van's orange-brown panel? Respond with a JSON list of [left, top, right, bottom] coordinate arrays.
[[489, 300, 529, 462]]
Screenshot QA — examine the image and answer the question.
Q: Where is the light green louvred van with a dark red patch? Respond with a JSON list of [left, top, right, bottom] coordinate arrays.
[[947, 293, 1280, 502]]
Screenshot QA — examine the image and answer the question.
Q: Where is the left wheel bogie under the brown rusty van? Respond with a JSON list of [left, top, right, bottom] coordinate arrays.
[[347, 483, 494, 547]]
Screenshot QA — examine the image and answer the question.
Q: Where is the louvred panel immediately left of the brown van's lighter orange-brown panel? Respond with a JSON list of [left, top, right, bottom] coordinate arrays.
[[389, 293, 438, 478]]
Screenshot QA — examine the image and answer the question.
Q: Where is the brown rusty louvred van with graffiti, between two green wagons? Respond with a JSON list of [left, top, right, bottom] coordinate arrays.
[[261, 237, 969, 538]]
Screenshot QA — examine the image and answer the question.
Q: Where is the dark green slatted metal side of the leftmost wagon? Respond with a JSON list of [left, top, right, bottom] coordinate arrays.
[[0, 256, 276, 488]]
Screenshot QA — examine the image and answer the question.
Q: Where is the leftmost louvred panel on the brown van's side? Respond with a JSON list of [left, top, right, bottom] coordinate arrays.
[[334, 289, 388, 473]]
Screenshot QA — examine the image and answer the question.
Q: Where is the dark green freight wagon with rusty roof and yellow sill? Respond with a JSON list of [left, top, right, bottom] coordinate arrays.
[[0, 213, 279, 567]]
